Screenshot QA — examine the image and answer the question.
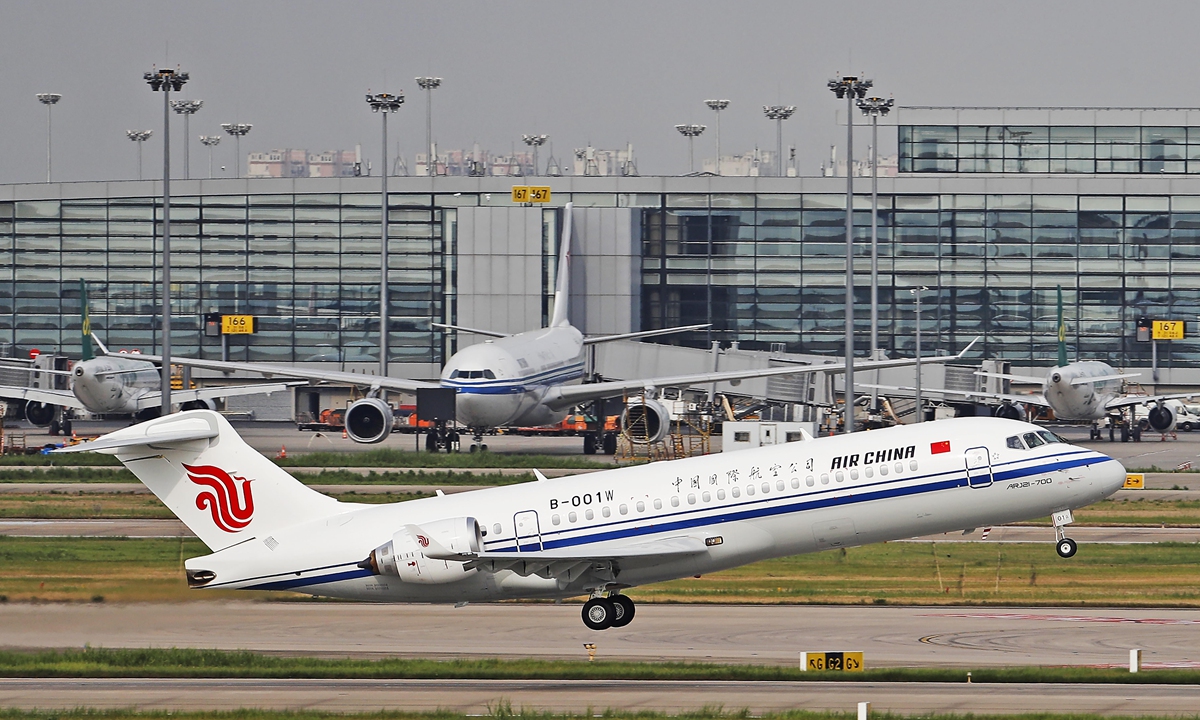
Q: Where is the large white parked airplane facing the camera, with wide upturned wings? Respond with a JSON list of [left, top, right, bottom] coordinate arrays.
[[138, 203, 973, 454]]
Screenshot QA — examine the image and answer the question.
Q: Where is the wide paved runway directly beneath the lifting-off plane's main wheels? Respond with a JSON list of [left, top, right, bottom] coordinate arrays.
[[0, 601, 1200, 667]]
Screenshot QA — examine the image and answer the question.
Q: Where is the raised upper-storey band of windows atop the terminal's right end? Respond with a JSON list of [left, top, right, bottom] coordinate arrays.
[[899, 125, 1200, 174]]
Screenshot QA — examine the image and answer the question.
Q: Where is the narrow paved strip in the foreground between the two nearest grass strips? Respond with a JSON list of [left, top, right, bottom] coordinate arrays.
[[0, 678, 1200, 715]]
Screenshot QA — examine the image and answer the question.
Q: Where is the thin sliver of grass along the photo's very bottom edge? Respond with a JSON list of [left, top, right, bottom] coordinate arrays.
[[0, 700, 1200, 720]]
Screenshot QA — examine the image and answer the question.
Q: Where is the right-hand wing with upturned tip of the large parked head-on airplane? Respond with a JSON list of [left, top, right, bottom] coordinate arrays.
[[544, 342, 974, 410]]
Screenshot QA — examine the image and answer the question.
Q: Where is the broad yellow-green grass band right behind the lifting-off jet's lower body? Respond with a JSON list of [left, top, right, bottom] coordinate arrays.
[[0, 537, 1200, 607]]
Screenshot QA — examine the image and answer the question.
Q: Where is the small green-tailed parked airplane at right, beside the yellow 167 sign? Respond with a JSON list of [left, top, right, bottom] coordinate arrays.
[[865, 287, 1196, 440]]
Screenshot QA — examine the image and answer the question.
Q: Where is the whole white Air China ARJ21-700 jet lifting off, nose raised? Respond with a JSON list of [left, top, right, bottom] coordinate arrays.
[[55, 410, 1126, 630]]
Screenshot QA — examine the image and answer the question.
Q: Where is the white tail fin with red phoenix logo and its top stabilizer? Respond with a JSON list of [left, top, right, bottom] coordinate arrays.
[[62, 410, 343, 552]]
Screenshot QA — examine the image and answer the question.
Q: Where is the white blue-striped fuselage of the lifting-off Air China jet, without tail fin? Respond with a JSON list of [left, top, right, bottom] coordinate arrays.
[[187, 418, 1124, 602]]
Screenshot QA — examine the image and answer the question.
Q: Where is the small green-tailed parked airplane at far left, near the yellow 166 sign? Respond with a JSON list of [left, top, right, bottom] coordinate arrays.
[[0, 280, 297, 434]]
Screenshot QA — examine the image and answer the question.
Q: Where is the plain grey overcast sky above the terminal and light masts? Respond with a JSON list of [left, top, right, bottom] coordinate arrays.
[[0, 0, 1200, 182]]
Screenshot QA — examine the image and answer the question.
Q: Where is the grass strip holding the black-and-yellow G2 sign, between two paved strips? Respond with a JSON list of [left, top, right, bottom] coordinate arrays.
[[0, 648, 1200, 685]]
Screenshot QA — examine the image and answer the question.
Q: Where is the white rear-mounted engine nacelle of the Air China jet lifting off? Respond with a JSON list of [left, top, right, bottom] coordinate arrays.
[[359, 517, 484, 584]]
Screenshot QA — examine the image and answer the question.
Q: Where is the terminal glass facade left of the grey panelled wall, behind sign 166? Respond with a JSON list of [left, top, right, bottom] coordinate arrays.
[[0, 193, 454, 362]]
